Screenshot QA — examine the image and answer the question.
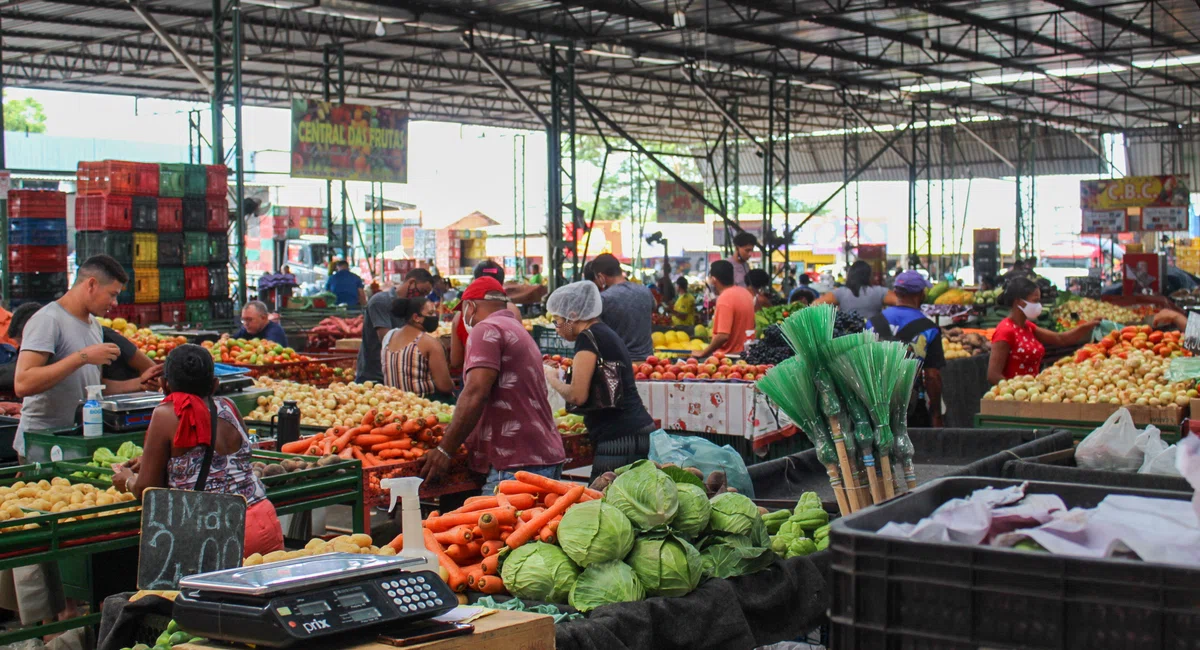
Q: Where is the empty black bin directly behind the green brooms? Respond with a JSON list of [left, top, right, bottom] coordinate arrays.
[[746, 428, 1073, 501]]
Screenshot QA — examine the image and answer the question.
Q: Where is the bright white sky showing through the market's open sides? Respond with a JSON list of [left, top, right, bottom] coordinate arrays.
[[6, 89, 1113, 263]]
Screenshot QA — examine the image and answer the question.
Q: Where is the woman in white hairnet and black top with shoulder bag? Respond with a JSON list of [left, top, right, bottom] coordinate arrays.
[[546, 281, 660, 480]]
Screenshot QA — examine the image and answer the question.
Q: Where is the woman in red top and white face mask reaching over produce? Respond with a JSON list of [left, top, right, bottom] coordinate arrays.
[[988, 277, 1099, 384]]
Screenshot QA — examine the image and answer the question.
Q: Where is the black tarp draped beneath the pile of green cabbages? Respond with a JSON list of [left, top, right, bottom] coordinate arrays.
[[554, 552, 830, 650]]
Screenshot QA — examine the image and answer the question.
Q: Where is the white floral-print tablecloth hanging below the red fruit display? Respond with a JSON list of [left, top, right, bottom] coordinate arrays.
[[637, 381, 792, 440]]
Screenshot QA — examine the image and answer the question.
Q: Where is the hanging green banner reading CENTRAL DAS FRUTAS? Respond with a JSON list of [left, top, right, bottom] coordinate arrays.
[[292, 100, 408, 182]]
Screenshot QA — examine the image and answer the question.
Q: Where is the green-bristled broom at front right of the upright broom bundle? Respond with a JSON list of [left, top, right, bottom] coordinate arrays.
[[835, 342, 906, 502]]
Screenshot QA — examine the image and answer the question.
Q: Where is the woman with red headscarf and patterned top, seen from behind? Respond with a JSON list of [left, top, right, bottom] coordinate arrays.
[[113, 344, 283, 556]]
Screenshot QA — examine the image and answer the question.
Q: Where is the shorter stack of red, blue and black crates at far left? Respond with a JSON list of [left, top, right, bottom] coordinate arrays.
[[7, 189, 67, 307]]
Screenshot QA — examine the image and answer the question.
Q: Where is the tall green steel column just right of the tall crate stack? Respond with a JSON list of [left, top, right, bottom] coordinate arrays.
[[212, 0, 247, 305]]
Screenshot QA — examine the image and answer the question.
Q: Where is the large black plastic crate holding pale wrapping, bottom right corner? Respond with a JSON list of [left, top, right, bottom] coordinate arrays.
[[829, 477, 1200, 650]]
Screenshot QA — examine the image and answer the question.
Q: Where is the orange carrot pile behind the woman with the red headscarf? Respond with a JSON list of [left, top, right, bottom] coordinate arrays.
[[280, 409, 444, 468]]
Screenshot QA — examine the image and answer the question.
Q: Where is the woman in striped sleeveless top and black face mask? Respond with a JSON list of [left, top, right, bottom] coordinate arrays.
[[380, 297, 454, 404]]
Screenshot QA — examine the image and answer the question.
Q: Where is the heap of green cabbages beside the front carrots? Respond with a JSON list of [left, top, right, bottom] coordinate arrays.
[[500, 461, 776, 612]]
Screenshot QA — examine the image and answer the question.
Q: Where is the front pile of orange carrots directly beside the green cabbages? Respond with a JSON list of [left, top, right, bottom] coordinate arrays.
[[388, 471, 602, 594]]
